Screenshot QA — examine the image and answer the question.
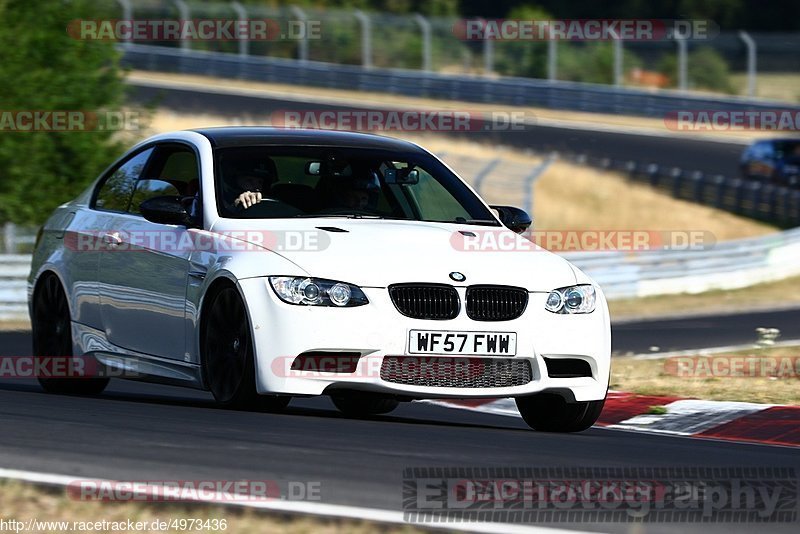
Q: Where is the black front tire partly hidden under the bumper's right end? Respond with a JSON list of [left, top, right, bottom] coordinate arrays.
[[514, 393, 606, 432]]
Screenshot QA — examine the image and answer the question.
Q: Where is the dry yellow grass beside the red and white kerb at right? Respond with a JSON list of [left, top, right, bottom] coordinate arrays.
[[611, 347, 800, 405]]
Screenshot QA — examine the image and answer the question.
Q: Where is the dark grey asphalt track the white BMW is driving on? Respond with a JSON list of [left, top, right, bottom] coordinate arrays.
[[0, 312, 800, 533]]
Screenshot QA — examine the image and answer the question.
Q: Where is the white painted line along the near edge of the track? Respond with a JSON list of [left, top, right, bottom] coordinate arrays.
[[0, 467, 588, 534]]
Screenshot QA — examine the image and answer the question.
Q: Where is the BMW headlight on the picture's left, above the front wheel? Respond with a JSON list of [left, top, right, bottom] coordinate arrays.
[[269, 276, 369, 308]]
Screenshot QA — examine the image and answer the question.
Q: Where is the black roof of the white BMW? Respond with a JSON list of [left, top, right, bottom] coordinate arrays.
[[192, 126, 424, 152]]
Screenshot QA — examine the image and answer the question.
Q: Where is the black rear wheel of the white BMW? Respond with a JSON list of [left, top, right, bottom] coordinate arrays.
[[31, 274, 108, 395]]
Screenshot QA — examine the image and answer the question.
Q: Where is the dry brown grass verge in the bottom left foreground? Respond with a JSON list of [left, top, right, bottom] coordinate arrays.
[[0, 480, 422, 534]]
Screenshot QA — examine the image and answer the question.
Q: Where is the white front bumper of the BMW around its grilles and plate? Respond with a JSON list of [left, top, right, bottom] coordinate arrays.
[[240, 278, 611, 401]]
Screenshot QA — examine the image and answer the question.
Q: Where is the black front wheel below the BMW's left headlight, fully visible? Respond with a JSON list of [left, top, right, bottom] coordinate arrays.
[[201, 287, 291, 411]]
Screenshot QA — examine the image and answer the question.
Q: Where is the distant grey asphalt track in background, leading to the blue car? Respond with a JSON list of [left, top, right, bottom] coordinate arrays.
[[128, 83, 742, 176]]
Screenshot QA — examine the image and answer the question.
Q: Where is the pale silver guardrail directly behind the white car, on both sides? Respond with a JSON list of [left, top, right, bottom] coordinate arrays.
[[9, 228, 800, 319]]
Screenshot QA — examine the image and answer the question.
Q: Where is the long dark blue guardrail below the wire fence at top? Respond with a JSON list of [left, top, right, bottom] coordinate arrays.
[[121, 44, 800, 118]]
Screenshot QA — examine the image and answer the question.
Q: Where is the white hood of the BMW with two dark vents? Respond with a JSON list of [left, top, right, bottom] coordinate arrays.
[[212, 218, 576, 292]]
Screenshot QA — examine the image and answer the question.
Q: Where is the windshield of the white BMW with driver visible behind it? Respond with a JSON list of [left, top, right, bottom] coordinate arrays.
[[215, 146, 499, 226]]
